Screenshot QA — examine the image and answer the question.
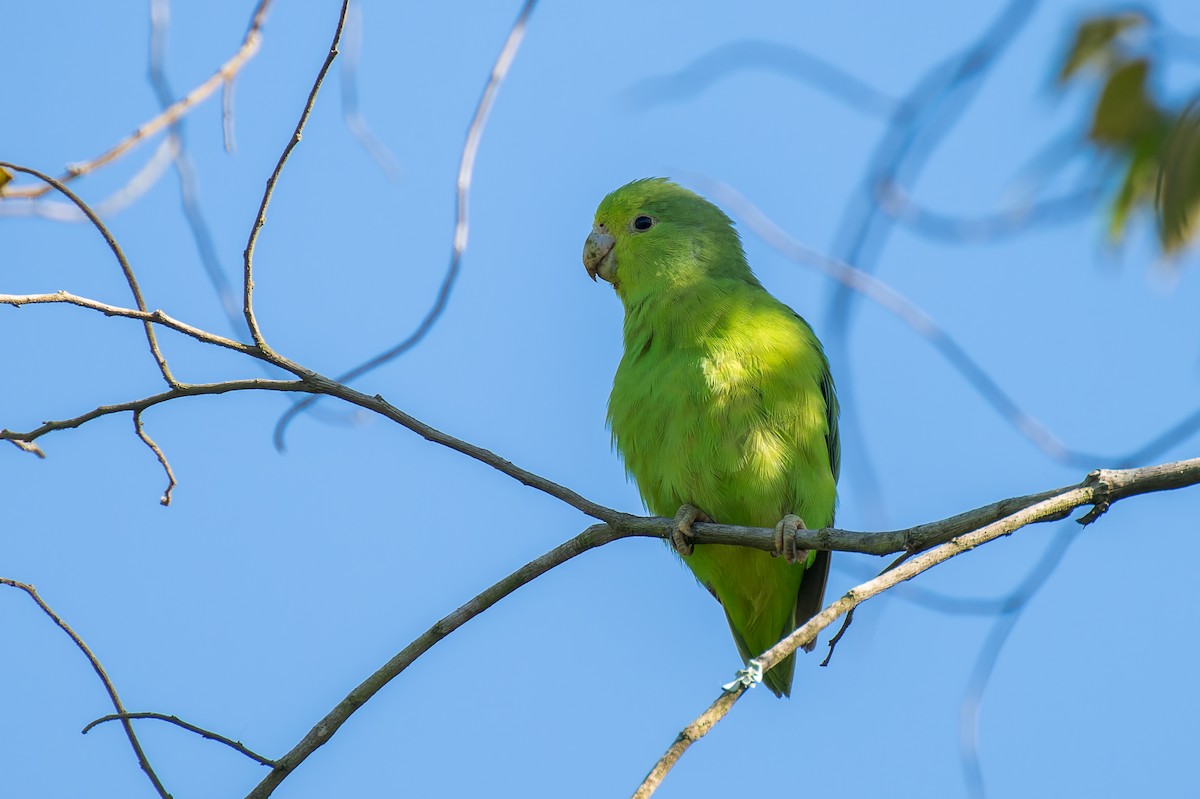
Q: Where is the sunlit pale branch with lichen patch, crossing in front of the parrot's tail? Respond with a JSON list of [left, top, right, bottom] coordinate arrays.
[[634, 458, 1200, 799]]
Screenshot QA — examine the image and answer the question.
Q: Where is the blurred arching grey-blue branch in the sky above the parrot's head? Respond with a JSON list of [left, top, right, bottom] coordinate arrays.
[[625, 38, 902, 116]]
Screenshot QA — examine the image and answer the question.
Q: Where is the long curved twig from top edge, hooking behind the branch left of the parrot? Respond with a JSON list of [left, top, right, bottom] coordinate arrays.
[[275, 0, 538, 452]]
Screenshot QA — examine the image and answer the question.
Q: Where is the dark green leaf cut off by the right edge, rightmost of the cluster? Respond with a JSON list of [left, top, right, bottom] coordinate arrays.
[[1154, 98, 1200, 254]]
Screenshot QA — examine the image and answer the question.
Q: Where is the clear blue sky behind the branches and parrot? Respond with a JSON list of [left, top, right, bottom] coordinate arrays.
[[0, 0, 1200, 797]]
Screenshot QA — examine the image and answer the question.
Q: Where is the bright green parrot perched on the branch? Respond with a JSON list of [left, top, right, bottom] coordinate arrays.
[[583, 178, 840, 696]]
